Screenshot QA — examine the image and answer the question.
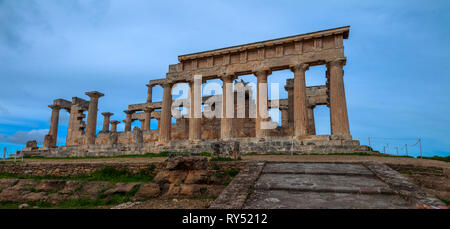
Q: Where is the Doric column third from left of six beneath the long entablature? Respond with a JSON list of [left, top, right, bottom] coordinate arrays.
[[220, 75, 236, 140]]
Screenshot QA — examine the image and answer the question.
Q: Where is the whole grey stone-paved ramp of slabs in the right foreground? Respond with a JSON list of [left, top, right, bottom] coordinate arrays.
[[242, 163, 415, 209]]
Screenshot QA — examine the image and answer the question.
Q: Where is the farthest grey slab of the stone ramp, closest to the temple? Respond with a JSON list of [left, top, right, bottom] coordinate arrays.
[[263, 163, 374, 176]]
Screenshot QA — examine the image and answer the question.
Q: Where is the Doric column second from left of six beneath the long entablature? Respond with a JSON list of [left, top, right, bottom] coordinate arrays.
[[189, 77, 202, 141]]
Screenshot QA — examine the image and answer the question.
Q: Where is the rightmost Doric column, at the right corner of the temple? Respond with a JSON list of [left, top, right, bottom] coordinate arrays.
[[327, 58, 351, 138]]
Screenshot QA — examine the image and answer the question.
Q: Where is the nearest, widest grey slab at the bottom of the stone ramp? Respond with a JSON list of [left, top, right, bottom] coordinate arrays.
[[244, 190, 414, 209]]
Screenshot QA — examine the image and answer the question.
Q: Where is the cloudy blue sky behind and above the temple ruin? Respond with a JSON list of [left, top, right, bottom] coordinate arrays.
[[0, 0, 450, 155]]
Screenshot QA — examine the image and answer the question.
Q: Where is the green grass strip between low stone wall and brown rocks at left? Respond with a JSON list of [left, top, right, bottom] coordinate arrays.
[[0, 166, 155, 183]]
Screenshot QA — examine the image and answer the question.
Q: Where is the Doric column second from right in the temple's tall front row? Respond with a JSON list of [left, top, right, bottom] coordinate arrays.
[[291, 64, 309, 138]]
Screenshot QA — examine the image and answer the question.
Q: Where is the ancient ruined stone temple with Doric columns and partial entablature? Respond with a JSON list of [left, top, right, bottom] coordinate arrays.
[[23, 27, 368, 156]]
